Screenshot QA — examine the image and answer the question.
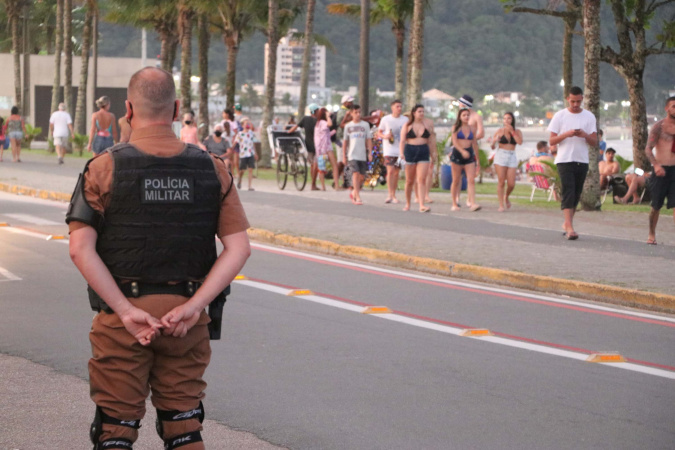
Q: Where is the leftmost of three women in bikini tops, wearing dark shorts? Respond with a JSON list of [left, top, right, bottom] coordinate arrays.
[[400, 105, 436, 212]]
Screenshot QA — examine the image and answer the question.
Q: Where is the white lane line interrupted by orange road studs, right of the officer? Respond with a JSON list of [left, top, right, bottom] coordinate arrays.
[[233, 280, 675, 380]]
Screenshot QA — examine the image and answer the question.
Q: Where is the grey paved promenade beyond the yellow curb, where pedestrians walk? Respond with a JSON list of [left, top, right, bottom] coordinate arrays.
[[0, 149, 675, 294]]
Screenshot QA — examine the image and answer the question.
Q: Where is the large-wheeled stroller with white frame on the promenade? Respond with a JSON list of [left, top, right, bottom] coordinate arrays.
[[267, 125, 308, 191]]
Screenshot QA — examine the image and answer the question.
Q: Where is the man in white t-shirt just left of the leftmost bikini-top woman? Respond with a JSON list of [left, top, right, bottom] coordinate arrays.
[[378, 100, 408, 203]]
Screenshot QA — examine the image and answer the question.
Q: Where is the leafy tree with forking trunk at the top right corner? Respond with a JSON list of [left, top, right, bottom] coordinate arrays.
[[600, 0, 675, 169]]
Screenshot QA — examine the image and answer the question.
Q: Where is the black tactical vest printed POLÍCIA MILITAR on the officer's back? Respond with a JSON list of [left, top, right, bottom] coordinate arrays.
[[96, 144, 221, 283]]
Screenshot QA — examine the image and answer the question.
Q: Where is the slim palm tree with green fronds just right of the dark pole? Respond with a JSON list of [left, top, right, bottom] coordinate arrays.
[[328, 0, 422, 102]]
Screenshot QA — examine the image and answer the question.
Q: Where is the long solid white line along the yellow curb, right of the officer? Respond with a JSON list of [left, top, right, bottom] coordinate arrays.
[[251, 242, 675, 323]]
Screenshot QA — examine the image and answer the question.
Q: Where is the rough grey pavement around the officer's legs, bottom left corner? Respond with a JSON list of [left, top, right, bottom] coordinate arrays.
[[0, 354, 282, 450]]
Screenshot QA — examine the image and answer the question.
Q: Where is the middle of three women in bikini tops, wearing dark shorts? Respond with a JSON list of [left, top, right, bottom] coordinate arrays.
[[450, 108, 481, 211]]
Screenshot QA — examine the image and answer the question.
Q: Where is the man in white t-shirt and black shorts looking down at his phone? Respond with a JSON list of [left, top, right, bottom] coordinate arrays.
[[548, 86, 598, 241]]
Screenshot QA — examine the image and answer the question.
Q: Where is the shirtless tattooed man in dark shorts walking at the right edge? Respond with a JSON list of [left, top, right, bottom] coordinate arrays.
[[645, 97, 675, 245]]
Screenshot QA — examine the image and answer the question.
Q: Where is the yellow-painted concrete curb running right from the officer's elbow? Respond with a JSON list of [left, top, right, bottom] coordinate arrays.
[[248, 228, 675, 313]]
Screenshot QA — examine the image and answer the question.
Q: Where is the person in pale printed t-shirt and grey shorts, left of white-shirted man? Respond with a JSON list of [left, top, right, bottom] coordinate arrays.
[[342, 105, 373, 205]]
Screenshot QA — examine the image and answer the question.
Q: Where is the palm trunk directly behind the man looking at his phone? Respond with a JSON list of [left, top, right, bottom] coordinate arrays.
[[580, 0, 602, 211]]
